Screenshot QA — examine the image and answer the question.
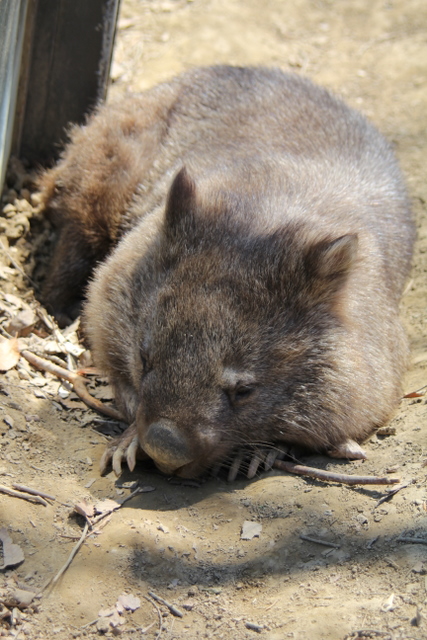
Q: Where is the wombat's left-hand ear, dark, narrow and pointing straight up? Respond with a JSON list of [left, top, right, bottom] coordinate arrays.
[[166, 167, 196, 236]]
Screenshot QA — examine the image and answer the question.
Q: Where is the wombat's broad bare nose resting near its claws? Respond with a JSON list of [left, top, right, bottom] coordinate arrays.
[[141, 420, 194, 473]]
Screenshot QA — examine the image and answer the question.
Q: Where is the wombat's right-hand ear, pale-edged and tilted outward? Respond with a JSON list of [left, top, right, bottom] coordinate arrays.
[[305, 234, 358, 282]]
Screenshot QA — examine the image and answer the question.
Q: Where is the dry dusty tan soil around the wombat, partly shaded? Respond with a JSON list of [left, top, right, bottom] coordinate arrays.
[[0, 0, 427, 640]]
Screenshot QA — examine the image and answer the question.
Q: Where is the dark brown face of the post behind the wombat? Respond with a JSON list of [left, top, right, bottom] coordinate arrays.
[[12, 0, 120, 164]]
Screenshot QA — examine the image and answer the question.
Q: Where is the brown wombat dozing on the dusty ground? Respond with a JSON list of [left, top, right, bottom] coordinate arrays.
[[42, 66, 414, 478]]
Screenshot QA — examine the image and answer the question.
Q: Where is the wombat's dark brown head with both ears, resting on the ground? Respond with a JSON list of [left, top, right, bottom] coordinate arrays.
[[87, 170, 357, 477]]
